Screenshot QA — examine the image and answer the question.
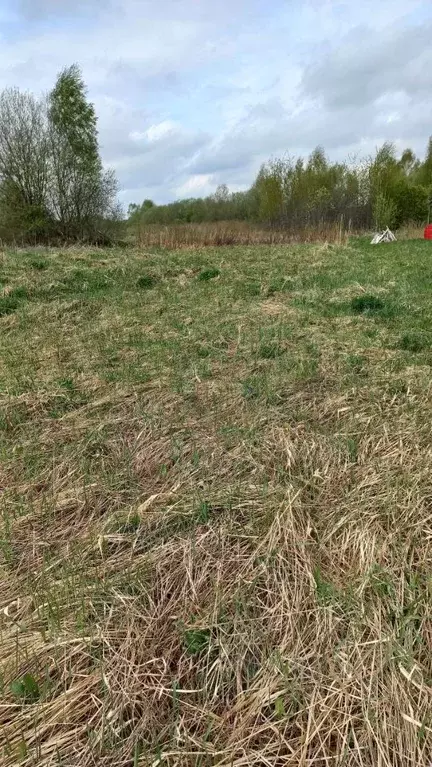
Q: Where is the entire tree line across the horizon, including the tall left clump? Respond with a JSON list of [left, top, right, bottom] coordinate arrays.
[[0, 65, 432, 242]]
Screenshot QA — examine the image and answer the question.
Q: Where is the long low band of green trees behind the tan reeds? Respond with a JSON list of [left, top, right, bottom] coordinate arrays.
[[129, 139, 432, 230]]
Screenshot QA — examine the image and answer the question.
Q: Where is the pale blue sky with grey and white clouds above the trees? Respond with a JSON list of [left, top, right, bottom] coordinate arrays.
[[0, 0, 432, 204]]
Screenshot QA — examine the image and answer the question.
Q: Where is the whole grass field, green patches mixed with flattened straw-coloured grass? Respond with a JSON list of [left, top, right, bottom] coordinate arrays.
[[0, 240, 432, 767]]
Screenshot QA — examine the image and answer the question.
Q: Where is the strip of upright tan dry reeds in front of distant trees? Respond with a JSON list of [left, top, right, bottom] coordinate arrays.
[[136, 221, 348, 249]]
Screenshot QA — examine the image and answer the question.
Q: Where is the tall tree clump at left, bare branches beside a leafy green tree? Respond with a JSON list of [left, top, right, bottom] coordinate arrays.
[[0, 65, 120, 242]]
